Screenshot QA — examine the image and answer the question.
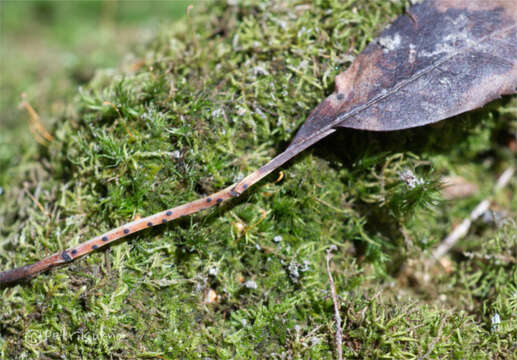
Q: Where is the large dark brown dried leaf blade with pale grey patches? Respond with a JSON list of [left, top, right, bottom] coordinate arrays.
[[291, 0, 517, 146]]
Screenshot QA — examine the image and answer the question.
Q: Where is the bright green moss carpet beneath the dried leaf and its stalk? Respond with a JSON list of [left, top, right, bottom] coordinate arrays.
[[0, 0, 517, 359]]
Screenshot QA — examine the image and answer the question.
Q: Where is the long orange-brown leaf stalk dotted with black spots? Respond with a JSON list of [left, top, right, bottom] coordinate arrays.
[[0, 129, 334, 285]]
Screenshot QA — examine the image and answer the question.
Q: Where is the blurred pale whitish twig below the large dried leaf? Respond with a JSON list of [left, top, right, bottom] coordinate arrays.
[[433, 167, 515, 260]]
